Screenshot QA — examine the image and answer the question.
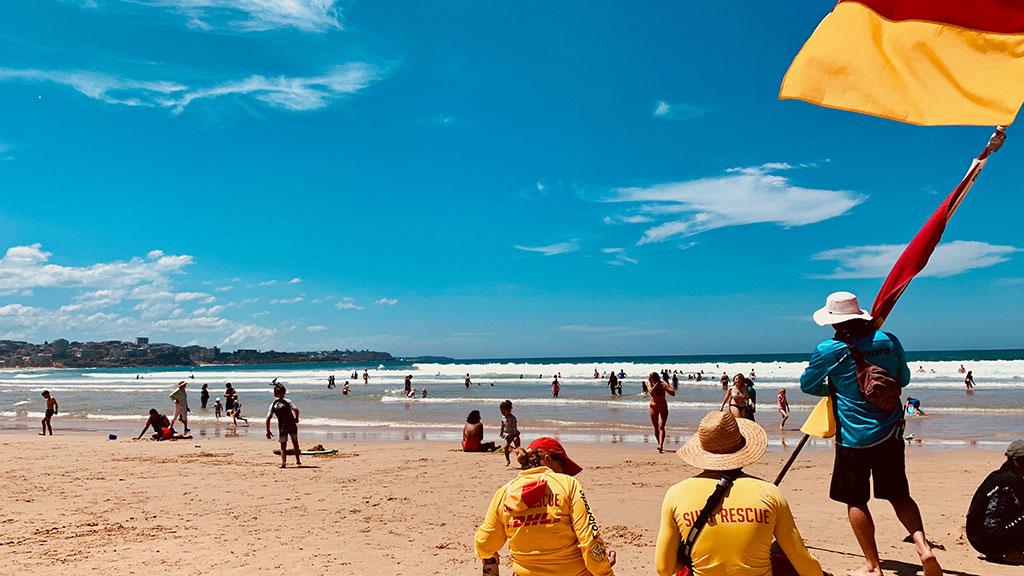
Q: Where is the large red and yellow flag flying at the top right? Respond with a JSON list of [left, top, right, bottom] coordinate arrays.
[[779, 0, 1024, 126]]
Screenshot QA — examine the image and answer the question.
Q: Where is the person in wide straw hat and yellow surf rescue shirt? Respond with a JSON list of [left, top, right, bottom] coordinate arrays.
[[654, 412, 824, 576]]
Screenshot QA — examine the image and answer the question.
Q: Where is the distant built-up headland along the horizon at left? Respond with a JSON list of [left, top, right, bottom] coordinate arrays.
[[0, 337, 453, 368]]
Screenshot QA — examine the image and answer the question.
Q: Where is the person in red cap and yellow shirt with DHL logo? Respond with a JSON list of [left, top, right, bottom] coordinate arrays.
[[474, 438, 615, 576]]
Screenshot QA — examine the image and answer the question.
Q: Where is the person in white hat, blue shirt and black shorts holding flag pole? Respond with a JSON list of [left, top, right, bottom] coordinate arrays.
[[800, 292, 942, 576]]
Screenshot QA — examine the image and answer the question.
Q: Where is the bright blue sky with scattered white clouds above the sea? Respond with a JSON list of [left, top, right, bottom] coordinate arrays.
[[0, 0, 1024, 359]]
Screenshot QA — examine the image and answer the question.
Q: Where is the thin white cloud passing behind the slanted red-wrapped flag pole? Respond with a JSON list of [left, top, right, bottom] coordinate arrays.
[[811, 240, 1020, 279]]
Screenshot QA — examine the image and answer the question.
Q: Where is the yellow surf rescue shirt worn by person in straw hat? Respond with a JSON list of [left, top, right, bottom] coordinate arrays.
[[655, 471, 821, 576]]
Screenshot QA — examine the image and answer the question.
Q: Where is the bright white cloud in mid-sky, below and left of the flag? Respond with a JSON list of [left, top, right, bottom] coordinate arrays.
[[603, 163, 866, 244]]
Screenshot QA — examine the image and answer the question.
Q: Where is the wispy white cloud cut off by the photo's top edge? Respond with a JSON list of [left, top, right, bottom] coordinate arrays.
[[84, 0, 341, 33]]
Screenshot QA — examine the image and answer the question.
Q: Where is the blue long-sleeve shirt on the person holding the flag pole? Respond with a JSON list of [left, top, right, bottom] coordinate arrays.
[[800, 331, 910, 448]]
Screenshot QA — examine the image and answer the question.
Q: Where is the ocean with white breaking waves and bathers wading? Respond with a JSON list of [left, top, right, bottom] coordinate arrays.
[[0, 351, 1024, 448]]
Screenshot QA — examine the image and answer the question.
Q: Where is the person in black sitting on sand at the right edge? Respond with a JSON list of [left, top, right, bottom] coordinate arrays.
[[967, 440, 1024, 564]]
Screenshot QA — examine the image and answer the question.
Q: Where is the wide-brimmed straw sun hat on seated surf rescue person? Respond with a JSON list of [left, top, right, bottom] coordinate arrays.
[[677, 412, 768, 470]]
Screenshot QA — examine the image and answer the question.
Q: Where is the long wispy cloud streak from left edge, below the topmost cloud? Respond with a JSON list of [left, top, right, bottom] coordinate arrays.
[[0, 63, 381, 114]]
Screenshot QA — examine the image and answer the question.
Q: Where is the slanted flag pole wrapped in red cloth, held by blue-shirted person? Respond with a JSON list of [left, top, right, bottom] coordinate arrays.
[[775, 126, 1007, 486]]
